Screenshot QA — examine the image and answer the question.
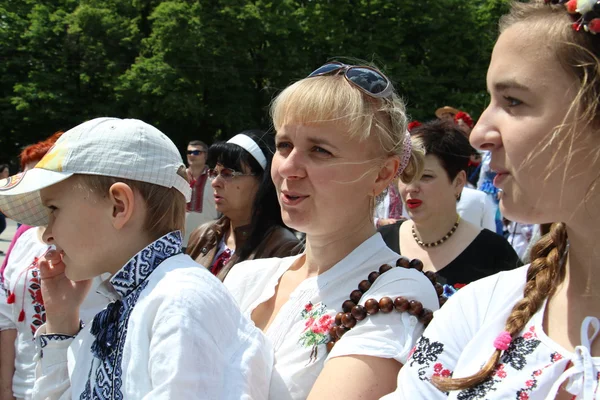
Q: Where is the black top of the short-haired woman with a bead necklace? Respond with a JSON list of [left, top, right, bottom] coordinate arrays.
[[378, 221, 523, 286]]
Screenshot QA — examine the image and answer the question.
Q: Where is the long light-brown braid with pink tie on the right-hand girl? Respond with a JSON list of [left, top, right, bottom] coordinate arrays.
[[432, 222, 567, 392]]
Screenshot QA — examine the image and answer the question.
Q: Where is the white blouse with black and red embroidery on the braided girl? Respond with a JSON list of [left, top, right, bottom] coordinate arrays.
[[382, 266, 600, 400]]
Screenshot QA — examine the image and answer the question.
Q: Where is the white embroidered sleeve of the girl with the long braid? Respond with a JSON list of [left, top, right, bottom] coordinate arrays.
[[383, 275, 499, 400]]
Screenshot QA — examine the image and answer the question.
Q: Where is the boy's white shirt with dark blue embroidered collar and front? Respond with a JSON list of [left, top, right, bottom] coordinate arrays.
[[34, 231, 273, 400]]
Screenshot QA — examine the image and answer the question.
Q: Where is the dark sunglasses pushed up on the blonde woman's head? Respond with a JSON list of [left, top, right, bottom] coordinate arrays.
[[308, 61, 394, 98]]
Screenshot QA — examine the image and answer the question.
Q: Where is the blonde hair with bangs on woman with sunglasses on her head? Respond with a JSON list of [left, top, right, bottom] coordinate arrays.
[[271, 71, 424, 183]]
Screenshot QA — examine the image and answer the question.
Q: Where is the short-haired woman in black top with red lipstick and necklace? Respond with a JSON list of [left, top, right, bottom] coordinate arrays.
[[379, 120, 520, 295]]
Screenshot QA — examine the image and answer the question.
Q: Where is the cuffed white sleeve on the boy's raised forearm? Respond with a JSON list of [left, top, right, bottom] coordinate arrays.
[[32, 324, 75, 400]]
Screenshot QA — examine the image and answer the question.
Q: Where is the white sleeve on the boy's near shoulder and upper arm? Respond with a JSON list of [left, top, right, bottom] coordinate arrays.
[[144, 277, 273, 399]]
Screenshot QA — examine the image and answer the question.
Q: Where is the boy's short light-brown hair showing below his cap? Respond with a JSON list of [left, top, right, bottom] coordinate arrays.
[[77, 175, 186, 239]]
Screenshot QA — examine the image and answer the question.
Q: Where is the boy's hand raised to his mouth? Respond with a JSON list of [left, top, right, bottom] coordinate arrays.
[[38, 250, 92, 336]]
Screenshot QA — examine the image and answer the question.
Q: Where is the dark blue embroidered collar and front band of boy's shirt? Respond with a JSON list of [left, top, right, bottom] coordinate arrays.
[[80, 231, 181, 400]]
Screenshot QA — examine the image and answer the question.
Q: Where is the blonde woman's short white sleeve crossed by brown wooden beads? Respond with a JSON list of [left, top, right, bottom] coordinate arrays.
[[327, 268, 439, 364]]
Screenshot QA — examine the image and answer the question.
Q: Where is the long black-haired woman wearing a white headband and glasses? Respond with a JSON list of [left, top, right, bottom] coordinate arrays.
[[186, 130, 301, 280]]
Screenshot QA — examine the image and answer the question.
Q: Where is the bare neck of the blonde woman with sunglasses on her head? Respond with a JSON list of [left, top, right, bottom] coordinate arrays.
[[302, 218, 376, 278]]
